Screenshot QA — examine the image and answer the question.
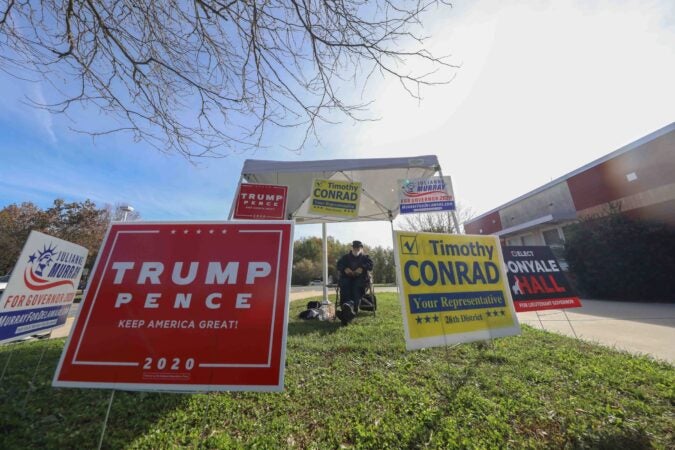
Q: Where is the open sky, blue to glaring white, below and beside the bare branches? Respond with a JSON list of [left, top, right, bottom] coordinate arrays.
[[0, 0, 675, 246]]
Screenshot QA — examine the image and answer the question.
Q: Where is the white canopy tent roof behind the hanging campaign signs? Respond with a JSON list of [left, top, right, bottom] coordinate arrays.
[[241, 155, 440, 223]]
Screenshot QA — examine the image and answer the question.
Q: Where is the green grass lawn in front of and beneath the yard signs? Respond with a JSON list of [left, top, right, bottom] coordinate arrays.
[[0, 293, 675, 449]]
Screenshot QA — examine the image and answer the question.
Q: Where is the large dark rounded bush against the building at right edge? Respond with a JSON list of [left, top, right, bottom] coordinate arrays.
[[565, 208, 675, 302]]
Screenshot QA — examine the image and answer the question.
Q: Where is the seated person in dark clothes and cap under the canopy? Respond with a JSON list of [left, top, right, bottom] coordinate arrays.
[[337, 241, 373, 323]]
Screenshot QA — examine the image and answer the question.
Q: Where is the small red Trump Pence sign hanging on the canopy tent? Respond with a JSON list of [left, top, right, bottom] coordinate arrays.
[[233, 183, 288, 220]]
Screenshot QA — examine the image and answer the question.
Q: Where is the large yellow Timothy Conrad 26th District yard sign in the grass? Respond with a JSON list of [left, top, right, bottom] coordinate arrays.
[[394, 231, 520, 350]]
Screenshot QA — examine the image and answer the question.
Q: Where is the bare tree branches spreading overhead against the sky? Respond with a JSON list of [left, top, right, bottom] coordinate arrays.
[[0, 0, 455, 158]]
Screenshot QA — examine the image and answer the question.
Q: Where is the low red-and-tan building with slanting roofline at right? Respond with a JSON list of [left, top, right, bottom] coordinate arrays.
[[464, 122, 675, 253]]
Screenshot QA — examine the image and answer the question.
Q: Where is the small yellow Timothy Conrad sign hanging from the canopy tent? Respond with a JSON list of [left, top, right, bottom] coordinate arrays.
[[309, 179, 361, 217]]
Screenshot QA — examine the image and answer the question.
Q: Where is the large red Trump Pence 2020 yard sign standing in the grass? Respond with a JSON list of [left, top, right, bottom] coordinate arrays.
[[53, 221, 293, 391]]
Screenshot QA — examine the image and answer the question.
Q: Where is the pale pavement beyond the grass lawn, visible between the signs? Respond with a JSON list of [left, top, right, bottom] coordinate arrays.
[[52, 292, 675, 364]]
